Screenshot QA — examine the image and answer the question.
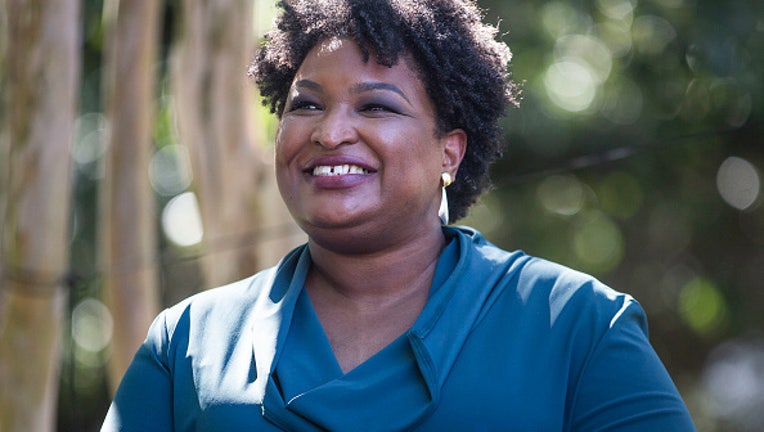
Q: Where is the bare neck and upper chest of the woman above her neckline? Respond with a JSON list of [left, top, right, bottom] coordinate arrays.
[[305, 227, 445, 372]]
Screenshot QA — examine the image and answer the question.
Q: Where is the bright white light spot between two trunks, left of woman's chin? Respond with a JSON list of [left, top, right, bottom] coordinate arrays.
[[162, 192, 204, 247]]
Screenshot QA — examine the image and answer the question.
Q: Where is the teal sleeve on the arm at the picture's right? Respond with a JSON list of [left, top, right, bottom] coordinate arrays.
[[566, 300, 695, 432]]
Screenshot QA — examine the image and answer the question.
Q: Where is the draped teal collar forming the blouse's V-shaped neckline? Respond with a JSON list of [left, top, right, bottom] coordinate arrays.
[[252, 227, 523, 431]]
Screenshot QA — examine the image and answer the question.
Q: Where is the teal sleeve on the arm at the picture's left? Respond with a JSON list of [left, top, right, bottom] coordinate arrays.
[[101, 312, 173, 432]]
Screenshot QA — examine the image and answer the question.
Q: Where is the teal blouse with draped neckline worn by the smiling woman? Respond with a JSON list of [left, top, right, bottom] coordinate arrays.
[[102, 227, 695, 432]]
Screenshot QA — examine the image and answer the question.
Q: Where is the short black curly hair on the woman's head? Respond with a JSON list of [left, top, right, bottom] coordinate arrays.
[[249, 0, 518, 221]]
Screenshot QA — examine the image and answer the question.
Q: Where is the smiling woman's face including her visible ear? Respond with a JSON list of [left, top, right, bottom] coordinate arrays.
[[276, 39, 466, 251]]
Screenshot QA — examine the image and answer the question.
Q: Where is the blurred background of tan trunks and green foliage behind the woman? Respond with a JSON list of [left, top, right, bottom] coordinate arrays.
[[0, 0, 764, 432]]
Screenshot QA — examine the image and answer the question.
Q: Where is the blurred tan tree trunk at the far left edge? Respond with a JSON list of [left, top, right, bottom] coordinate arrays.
[[0, 0, 80, 432]]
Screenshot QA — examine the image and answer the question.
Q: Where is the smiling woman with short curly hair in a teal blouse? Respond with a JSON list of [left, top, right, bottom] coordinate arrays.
[[103, 0, 693, 431]]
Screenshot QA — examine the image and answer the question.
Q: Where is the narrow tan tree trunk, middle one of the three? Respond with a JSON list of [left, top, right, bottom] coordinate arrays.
[[99, 0, 161, 391]]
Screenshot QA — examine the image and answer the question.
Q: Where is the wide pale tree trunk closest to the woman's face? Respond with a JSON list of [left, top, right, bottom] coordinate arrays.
[[171, 0, 271, 287]]
